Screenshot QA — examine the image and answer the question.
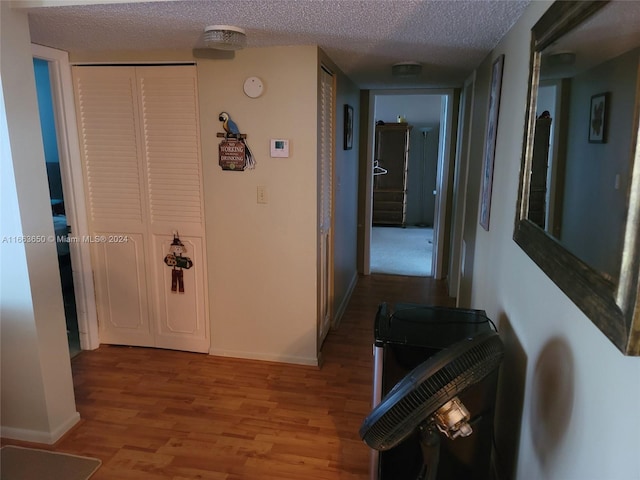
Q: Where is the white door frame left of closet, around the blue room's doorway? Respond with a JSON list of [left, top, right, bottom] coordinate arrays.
[[31, 44, 100, 350]]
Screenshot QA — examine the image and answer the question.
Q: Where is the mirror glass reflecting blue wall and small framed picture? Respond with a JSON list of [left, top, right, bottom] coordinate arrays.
[[527, 2, 640, 283]]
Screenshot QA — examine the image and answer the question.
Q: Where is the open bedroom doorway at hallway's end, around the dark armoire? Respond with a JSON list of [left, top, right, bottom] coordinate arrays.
[[359, 89, 454, 278]]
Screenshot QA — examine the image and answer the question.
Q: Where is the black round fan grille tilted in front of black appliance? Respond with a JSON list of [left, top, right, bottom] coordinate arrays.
[[360, 332, 504, 450]]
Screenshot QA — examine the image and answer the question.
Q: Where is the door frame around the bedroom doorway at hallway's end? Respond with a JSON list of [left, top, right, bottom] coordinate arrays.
[[362, 88, 455, 279]]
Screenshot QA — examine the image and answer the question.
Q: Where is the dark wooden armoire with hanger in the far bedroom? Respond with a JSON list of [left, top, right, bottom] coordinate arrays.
[[373, 123, 412, 227]]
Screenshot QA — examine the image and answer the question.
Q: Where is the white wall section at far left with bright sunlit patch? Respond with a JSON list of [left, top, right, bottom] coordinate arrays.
[[0, 2, 79, 443]]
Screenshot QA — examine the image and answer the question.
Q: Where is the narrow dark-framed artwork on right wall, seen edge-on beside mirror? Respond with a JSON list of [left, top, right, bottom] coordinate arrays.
[[480, 55, 504, 231]]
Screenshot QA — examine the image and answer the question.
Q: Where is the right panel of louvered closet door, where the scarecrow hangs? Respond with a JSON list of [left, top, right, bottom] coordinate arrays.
[[136, 66, 210, 352]]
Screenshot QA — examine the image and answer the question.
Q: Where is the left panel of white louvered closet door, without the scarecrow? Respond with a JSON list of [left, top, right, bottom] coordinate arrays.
[[73, 67, 155, 346]]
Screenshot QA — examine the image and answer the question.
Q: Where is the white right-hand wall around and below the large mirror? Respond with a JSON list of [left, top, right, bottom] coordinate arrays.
[[472, 1, 640, 480]]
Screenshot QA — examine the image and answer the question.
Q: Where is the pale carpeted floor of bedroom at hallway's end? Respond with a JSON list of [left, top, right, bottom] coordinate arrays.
[[371, 227, 433, 277]]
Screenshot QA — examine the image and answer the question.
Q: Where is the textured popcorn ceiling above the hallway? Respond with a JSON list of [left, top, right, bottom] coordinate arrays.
[[23, 0, 529, 88]]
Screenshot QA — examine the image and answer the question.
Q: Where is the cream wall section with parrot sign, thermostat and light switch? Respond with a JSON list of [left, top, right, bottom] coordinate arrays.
[[198, 46, 318, 364]]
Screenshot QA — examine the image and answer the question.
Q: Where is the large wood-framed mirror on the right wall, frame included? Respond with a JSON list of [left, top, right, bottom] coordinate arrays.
[[513, 1, 640, 355]]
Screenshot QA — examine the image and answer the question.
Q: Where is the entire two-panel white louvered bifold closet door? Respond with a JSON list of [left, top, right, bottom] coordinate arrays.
[[73, 66, 210, 352]]
